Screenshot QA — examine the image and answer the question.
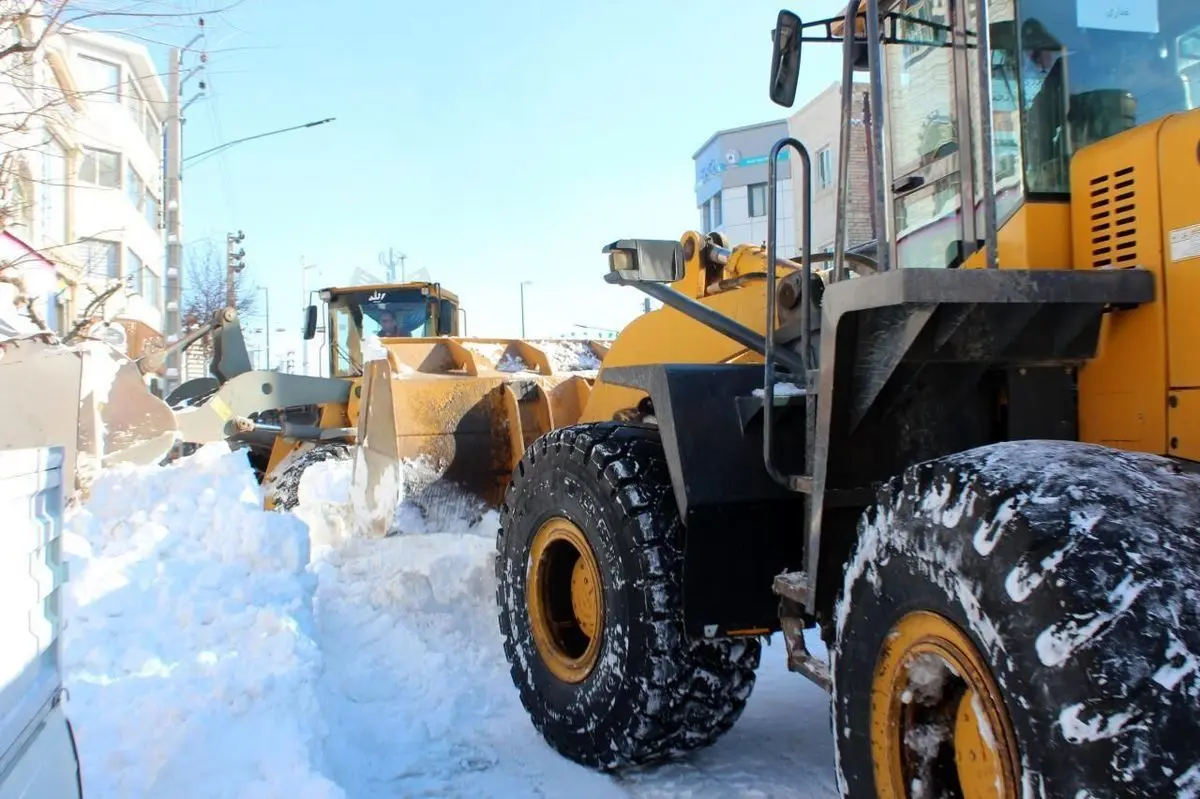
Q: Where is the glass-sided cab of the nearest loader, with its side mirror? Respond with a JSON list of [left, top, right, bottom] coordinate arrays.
[[772, 0, 1200, 269]]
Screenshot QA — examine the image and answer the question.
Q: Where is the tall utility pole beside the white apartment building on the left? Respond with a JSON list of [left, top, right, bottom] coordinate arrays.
[[162, 19, 206, 392]]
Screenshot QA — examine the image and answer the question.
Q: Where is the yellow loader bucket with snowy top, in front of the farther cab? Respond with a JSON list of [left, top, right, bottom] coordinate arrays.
[[352, 338, 605, 536]]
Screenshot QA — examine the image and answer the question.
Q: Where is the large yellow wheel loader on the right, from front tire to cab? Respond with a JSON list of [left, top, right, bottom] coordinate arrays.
[[497, 0, 1200, 799]]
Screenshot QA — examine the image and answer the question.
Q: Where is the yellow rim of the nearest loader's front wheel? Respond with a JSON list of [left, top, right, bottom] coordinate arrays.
[[526, 517, 605, 683]]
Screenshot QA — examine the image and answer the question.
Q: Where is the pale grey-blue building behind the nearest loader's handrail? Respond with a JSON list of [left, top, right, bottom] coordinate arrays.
[[692, 120, 799, 258]]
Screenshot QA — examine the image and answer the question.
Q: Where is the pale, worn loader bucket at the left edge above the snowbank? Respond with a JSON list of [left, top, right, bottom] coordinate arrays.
[[0, 335, 176, 485]]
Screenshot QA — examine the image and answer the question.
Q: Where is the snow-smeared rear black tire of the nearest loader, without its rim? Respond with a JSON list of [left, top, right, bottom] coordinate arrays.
[[830, 441, 1200, 799]]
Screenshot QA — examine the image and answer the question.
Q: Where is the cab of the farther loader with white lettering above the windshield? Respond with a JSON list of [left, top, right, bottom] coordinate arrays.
[[322, 283, 460, 378]]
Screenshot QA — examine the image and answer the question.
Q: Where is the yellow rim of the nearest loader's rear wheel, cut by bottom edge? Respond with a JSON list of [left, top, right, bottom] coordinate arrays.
[[871, 611, 1020, 799]]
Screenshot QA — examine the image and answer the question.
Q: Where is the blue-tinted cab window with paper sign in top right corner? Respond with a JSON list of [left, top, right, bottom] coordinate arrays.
[[1018, 0, 1200, 193]]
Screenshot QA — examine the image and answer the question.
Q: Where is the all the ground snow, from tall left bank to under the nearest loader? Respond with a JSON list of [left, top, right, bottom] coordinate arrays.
[[64, 446, 835, 799]]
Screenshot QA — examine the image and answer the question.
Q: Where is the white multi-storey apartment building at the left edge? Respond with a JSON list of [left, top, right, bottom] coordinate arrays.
[[0, 7, 166, 350]]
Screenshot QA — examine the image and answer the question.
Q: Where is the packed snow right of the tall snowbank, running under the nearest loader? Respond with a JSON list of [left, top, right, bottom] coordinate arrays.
[[296, 461, 834, 799]]
